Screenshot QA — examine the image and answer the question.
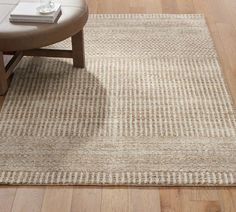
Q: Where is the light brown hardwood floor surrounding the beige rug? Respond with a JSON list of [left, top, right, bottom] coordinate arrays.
[[0, 0, 236, 212]]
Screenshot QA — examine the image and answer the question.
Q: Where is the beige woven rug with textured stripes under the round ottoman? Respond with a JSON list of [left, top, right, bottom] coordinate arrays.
[[0, 15, 236, 186]]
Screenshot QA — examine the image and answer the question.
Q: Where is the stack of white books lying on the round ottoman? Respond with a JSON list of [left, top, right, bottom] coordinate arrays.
[[9, 2, 61, 23]]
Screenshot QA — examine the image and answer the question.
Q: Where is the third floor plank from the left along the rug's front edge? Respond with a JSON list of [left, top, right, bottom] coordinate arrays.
[[41, 186, 73, 212]]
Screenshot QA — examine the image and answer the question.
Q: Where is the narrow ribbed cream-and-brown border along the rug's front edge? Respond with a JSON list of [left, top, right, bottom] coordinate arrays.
[[0, 171, 236, 186]]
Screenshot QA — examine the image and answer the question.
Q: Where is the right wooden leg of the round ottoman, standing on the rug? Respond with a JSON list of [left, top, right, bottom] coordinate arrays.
[[71, 30, 85, 68]]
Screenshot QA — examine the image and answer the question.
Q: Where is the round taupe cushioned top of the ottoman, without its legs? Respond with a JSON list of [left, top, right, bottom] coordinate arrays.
[[0, 0, 88, 51]]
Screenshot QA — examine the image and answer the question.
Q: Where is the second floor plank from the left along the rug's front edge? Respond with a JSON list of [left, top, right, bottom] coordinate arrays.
[[12, 186, 45, 212]]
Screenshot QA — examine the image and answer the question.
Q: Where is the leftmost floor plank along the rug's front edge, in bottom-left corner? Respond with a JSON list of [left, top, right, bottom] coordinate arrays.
[[0, 186, 16, 212]]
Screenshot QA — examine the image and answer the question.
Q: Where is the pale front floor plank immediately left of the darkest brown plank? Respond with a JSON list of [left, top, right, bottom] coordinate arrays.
[[129, 188, 161, 212]]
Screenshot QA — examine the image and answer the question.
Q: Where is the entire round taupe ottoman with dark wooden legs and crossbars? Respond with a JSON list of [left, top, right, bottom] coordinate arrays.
[[0, 0, 88, 95]]
